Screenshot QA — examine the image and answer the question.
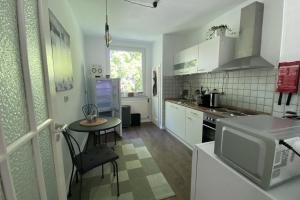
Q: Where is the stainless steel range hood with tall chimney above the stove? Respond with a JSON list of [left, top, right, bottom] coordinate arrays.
[[216, 2, 274, 71]]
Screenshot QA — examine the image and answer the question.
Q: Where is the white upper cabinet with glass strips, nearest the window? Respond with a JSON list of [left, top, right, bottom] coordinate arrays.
[[174, 45, 199, 75]]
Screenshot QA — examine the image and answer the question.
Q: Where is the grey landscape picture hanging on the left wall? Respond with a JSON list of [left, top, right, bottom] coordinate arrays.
[[49, 10, 74, 92]]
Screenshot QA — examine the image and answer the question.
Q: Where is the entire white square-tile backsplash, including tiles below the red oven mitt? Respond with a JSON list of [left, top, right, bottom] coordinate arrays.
[[164, 69, 300, 117]]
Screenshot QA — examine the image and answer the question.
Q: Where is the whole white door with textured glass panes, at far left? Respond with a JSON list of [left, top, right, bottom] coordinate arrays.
[[0, 0, 66, 200]]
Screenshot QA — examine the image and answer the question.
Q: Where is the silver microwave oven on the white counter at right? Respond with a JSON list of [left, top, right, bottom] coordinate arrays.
[[214, 115, 300, 189]]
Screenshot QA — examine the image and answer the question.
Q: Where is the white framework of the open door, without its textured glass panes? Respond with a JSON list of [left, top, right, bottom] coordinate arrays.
[[0, 0, 67, 200]]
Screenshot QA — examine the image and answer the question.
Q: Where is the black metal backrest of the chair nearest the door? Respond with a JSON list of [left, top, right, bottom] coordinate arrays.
[[62, 129, 82, 166]]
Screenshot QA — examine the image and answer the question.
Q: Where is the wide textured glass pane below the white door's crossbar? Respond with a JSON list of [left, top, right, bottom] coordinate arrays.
[[9, 143, 40, 200]]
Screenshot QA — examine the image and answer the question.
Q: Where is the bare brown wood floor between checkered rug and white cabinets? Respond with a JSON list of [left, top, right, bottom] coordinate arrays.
[[123, 123, 192, 200]]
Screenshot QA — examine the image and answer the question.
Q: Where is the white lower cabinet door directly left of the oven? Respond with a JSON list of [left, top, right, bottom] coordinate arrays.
[[185, 109, 203, 146]]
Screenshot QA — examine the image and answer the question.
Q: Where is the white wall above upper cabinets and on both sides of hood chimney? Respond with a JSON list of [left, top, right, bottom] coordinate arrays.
[[170, 0, 284, 66]]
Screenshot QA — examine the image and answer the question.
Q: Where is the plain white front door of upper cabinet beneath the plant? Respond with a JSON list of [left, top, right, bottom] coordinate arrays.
[[198, 38, 220, 72]]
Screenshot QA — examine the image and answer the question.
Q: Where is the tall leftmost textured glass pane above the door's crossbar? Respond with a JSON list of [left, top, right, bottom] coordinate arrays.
[[0, 0, 29, 144]]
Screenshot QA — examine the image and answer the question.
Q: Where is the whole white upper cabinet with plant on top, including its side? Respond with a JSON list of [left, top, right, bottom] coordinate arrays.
[[198, 37, 235, 73]]
